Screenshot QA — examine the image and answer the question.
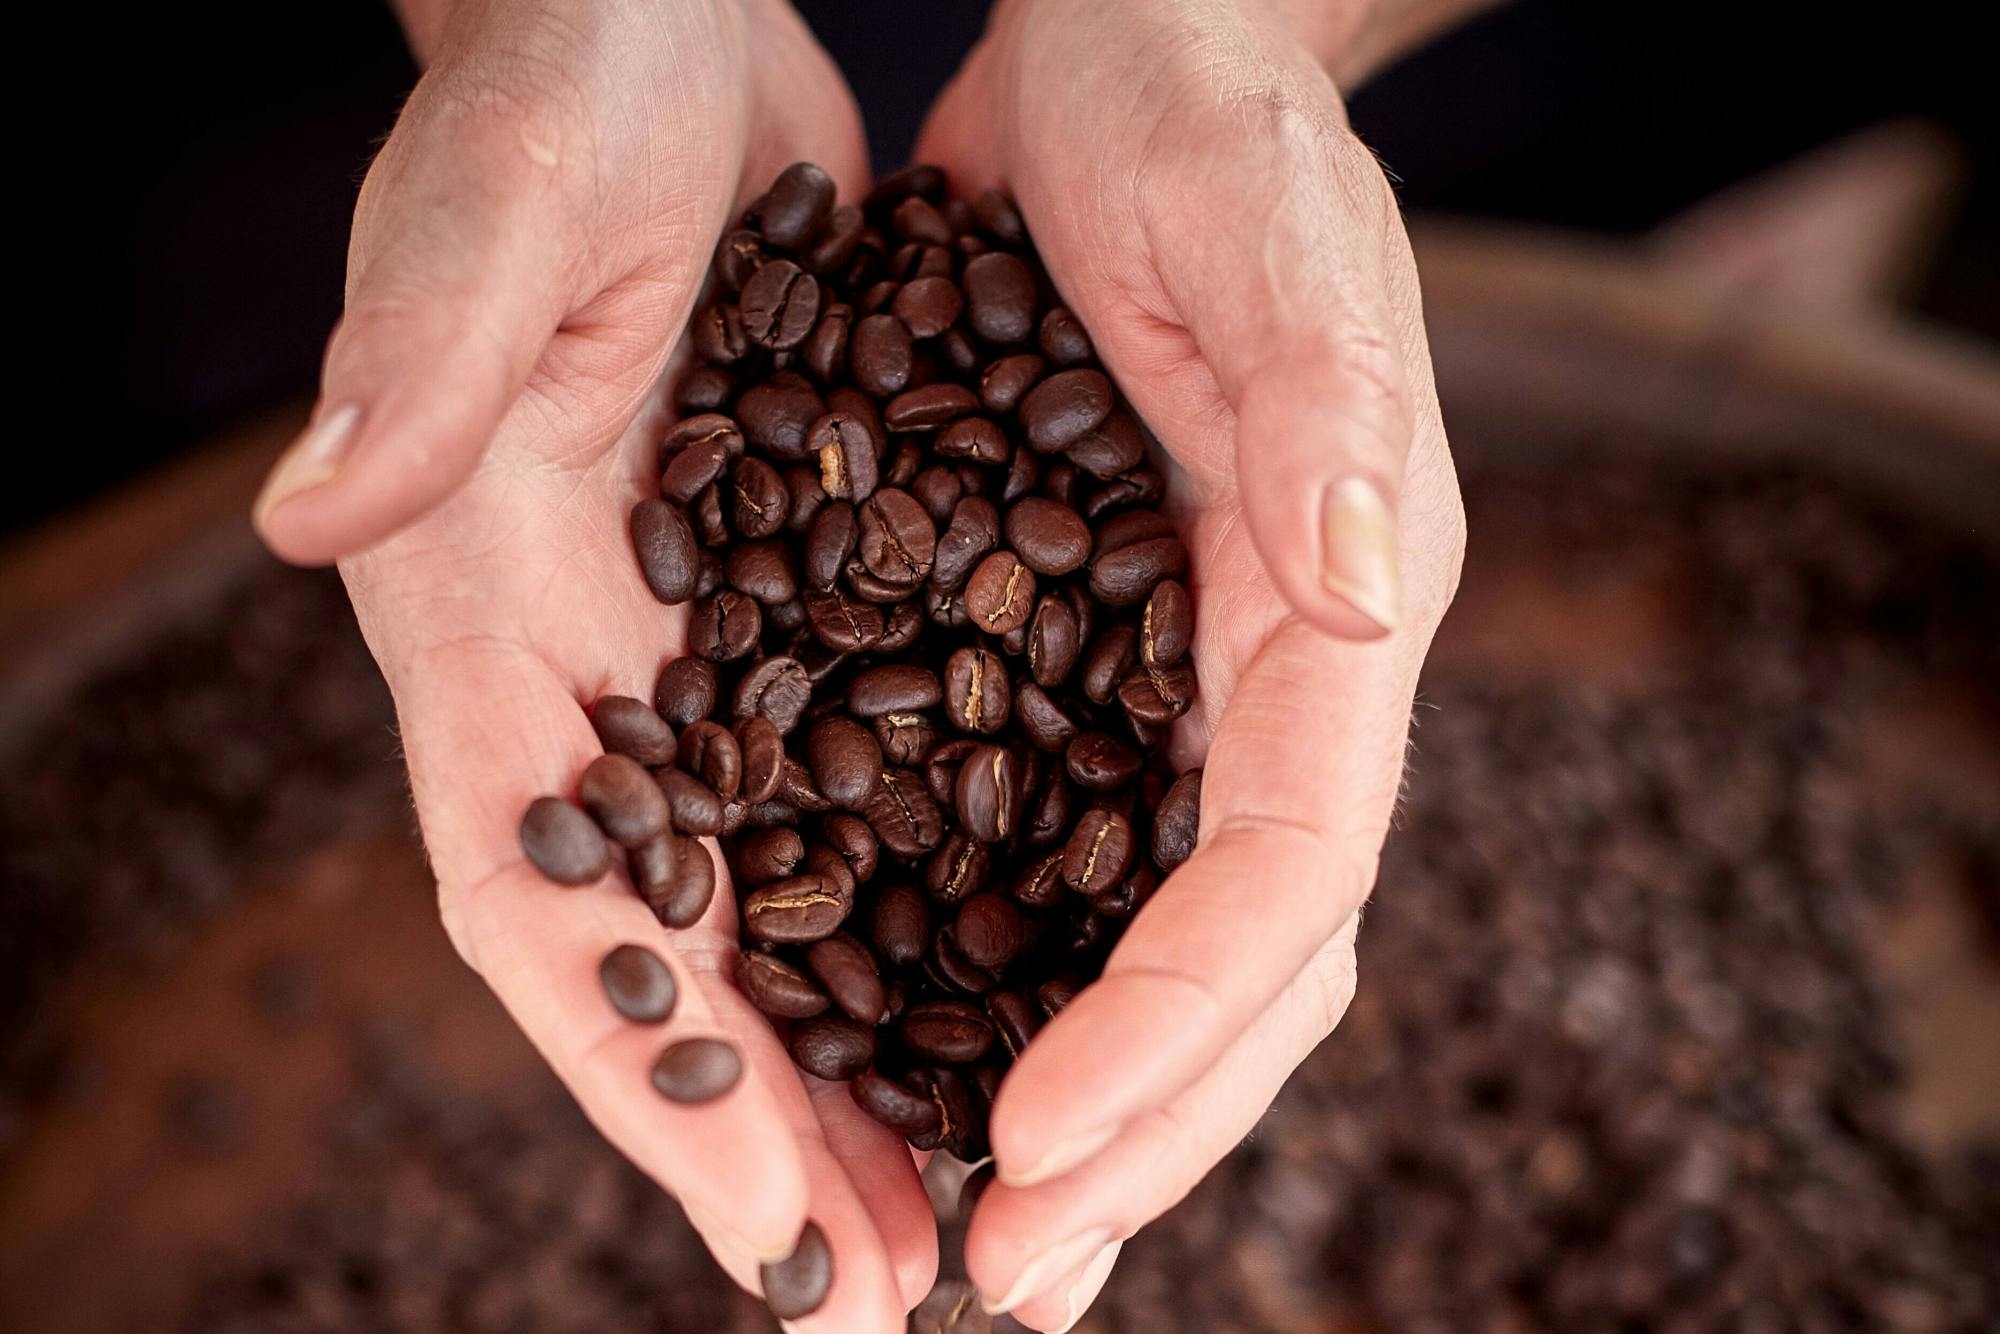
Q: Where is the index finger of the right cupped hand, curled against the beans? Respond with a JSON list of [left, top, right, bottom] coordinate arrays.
[[992, 620, 1420, 1184]]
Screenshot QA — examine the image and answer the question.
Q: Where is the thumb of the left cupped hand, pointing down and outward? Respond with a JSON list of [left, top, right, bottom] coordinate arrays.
[[254, 70, 586, 564]]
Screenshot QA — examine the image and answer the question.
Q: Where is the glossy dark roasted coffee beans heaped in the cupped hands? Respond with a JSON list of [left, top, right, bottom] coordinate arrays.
[[522, 164, 1200, 1160]]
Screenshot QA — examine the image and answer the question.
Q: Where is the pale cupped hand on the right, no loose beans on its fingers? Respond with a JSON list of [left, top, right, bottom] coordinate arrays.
[[920, 0, 1464, 1330]]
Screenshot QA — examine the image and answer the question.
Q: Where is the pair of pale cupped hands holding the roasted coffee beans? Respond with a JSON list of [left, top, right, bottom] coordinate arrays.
[[258, 0, 1464, 1334]]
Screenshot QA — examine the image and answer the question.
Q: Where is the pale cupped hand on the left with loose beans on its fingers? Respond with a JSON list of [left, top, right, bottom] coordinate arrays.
[[274, 0, 936, 1334]]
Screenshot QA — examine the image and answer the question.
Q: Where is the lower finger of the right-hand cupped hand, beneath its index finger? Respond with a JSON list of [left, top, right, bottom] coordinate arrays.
[[966, 914, 1360, 1324]]
